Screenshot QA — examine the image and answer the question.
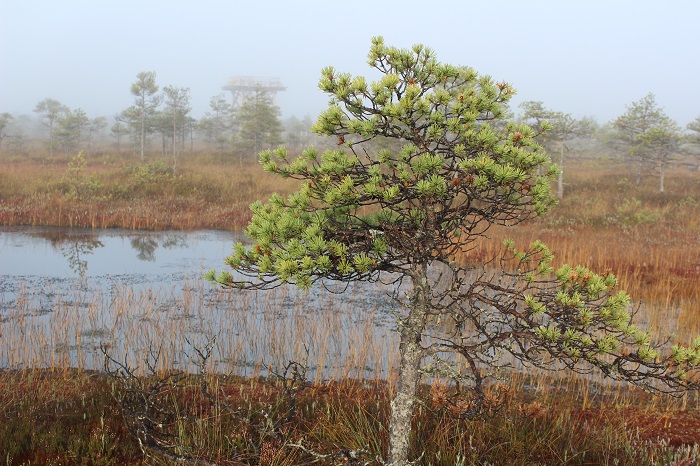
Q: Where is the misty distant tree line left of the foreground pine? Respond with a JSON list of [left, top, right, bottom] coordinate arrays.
[[0, 71, 320, 165]]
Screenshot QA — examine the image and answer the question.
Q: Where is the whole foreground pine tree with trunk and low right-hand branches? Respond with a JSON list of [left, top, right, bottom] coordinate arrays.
[[208, 38, 700, 466]]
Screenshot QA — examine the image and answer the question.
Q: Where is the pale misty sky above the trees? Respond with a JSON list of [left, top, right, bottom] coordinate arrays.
[[0, 0, 700, 126]]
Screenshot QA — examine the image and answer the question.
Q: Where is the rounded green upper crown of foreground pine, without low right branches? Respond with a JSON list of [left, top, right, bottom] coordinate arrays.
[[210, 38, 557, 288]]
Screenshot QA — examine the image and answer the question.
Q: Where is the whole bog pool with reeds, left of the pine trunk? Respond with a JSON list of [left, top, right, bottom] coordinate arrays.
[[0, 228, 395, 378]]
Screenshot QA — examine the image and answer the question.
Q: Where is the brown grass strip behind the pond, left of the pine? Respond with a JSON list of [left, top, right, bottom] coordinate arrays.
[[0, 150, 294, 230]]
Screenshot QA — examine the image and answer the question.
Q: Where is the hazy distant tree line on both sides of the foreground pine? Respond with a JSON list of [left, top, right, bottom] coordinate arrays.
[[0, 71, 700, 189]]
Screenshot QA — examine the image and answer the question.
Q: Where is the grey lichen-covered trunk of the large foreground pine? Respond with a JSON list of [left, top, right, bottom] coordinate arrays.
[[386, 267, 428, 466]]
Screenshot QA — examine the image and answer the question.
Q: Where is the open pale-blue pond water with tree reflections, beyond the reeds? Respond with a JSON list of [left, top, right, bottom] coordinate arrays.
[[0, 228, 235, 285]]
